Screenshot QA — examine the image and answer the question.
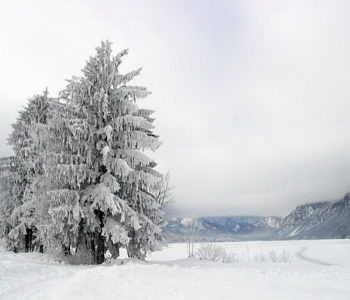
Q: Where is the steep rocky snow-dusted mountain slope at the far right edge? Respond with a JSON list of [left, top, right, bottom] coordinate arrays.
[[280, 194, 350, 239]]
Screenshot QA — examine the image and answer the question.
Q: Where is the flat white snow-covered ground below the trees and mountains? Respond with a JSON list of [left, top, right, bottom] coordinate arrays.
[[0, 240, 350, 300]]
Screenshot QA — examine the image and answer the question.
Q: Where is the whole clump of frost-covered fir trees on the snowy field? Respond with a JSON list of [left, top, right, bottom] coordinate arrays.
[[0, 42, 168, 263]]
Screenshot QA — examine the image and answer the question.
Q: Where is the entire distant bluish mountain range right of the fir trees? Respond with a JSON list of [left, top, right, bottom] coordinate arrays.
[[164, 193, 350, 241]]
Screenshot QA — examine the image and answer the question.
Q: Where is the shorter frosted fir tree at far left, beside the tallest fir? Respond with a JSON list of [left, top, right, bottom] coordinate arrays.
[[7, 90, 49, 251]]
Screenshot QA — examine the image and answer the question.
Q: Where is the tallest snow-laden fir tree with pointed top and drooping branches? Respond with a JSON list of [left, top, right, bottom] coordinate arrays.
[[43, 42, 163, 263]]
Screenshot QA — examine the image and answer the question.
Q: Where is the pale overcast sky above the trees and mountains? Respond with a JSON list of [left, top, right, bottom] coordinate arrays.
[[0, 0, 350, 216]]
